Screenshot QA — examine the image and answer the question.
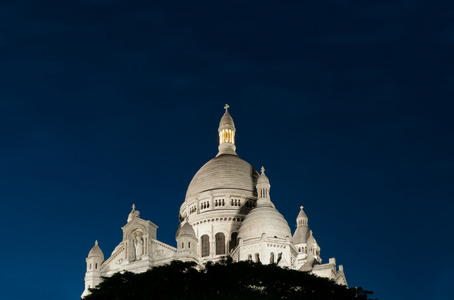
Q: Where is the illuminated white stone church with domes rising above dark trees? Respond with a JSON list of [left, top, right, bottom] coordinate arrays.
[[82, 105, 347, 297]]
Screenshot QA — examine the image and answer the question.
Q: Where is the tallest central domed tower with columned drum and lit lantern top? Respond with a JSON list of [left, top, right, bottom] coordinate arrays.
[[179, 105, 259, 261]]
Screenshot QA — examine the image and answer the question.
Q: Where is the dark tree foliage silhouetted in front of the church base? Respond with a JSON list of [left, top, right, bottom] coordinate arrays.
[[84, 259, 372, 300]]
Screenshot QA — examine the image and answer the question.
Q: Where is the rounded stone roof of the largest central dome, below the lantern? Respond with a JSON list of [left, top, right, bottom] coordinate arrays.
[[186, 154, 259, 200]]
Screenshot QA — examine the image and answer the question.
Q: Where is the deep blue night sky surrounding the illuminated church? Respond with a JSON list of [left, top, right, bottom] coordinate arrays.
[[0, 0, 454, 300]]
